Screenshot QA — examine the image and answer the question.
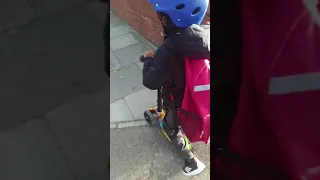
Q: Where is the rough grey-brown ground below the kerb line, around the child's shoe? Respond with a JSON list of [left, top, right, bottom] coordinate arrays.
[[110, 126, 210, 180]]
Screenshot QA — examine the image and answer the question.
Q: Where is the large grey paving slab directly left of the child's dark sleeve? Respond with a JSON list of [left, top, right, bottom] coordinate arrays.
[[110, 64, 143, 102]]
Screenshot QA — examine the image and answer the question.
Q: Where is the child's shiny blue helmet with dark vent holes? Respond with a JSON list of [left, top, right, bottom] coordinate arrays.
[[148, 0, 209, 28]]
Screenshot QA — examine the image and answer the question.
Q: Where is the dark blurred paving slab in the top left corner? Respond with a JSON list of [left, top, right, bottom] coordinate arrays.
[[0, 0, 35, 32]]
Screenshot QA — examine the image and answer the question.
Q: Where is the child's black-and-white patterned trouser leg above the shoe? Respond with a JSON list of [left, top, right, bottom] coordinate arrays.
[[165, 110, 193, 160]]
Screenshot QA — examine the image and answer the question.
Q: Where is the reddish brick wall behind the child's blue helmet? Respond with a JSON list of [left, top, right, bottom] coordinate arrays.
[[110, 0, 210, 45]]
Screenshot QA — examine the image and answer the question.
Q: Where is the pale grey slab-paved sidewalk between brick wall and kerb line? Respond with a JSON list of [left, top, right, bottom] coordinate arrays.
[[110, 12, 157, 129]]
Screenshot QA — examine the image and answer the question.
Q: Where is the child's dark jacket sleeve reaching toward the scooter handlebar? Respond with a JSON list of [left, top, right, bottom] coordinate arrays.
[[142, 46, 174, 90]]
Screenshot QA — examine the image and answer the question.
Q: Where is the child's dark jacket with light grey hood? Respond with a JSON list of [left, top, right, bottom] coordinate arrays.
[[143, 25, 210, 106]]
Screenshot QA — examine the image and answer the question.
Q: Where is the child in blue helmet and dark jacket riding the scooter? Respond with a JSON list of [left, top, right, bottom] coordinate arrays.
[[142, 0, 210, 176]]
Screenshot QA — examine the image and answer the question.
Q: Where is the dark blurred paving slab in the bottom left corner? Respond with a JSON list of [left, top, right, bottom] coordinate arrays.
[[0, 119, 74, 180]]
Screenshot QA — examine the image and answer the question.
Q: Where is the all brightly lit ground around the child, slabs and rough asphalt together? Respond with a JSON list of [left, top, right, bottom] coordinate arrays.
[[110, 13, 210, 180]]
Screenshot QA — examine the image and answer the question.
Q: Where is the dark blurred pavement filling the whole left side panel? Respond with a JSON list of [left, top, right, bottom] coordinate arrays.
[[0, 0, 109, 180]]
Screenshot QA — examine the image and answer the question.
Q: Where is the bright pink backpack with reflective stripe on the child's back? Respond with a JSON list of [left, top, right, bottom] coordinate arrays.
[[178, 58, 210, 144]]
